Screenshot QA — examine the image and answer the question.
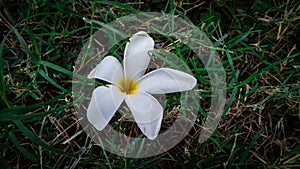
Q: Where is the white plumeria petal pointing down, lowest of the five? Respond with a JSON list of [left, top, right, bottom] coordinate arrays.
[[125, 92, 163, 140]]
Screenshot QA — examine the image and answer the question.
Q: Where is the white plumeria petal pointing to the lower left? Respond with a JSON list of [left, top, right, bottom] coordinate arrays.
[[87, 85, 125, 130]]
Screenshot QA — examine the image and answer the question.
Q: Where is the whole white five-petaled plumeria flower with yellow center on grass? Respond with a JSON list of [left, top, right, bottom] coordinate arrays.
[[87, 31, 197, 140]]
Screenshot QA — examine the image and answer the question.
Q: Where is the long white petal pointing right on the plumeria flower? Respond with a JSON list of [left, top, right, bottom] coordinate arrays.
[[138, 68, 197, 94]]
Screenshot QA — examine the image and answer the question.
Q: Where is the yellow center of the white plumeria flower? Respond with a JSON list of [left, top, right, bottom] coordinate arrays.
[[118, 78, 138, 95]]
